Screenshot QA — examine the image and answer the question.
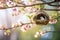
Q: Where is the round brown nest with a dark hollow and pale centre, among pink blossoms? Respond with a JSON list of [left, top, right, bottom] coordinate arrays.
[[33, 12, 49, 25]]
